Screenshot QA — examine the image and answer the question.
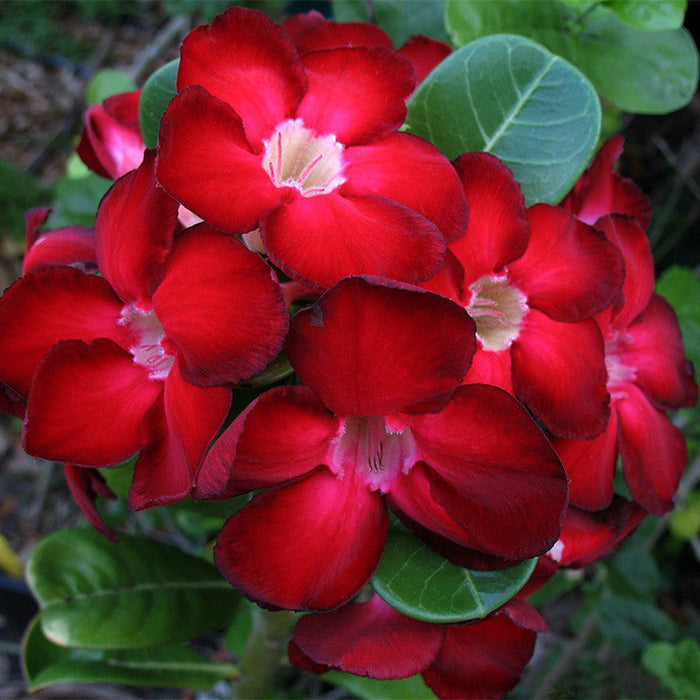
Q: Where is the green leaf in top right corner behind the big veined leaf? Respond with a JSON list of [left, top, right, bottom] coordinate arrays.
[[446, 0, 698, 114]]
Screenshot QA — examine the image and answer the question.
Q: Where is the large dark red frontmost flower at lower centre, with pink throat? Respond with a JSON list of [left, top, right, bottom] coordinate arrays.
[[195, 278, 567, 609]]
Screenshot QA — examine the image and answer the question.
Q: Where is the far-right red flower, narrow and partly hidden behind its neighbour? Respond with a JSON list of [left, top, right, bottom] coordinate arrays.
[[555, 214, 698, 515]]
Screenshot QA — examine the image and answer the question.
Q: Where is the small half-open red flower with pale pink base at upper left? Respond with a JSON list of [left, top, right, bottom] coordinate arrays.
[[77, 90, 146, 180]]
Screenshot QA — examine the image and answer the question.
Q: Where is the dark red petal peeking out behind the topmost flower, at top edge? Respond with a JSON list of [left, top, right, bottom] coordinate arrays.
[[282, 10, 392, 54]]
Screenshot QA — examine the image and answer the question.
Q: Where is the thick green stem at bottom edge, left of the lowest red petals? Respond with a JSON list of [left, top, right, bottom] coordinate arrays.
[[232, 606, 297, 699]]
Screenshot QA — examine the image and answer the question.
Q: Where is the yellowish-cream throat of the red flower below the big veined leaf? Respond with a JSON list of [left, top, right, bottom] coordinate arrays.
[[466, 275, 528, 352]]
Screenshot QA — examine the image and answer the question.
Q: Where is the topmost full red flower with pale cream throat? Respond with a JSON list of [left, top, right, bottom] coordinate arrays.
[[157, 7, 467, 288]]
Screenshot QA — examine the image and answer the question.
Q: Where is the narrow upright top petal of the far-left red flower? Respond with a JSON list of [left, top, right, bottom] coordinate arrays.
[[95, 151, 178, 303]]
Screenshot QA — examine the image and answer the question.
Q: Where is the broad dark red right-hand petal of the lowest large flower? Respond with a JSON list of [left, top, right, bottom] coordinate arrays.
[[399, 384, 568, 560]]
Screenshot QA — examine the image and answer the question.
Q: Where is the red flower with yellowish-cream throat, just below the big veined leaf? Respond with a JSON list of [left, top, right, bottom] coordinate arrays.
[[425, 153, 623, 437]]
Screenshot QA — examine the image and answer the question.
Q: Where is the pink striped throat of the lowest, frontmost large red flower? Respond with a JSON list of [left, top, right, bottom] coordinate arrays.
[[329, 416, 416, 493]]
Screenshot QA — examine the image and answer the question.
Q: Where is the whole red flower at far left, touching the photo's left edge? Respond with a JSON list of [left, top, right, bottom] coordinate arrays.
[[0, 153, 288, 508]]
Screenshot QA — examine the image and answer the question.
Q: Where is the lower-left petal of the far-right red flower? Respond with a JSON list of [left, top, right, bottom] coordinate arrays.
[[552, 411, 618, 510]]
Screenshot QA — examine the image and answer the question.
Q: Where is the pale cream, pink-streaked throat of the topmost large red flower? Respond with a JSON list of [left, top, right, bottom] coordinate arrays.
[[262, 119, 345, 197]]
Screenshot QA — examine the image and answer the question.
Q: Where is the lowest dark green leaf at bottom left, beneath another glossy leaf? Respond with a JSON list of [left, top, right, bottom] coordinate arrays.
[[23, 616, 238, 692]]
